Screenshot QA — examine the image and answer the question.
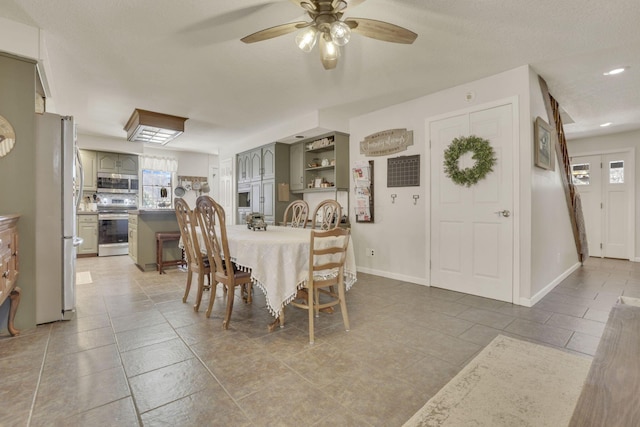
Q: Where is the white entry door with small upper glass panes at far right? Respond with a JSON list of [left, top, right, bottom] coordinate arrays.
[[571, 152, 633, 259]]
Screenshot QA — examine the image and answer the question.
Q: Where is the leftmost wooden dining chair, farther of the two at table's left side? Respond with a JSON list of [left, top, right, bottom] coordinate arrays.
[[173, 198, 215, 311]]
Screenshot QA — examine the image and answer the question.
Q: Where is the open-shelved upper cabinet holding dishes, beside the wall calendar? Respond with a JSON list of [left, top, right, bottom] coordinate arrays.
[[301, 132, 349, 193]]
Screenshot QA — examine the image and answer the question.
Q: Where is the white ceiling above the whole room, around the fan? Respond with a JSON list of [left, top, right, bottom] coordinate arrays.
[[0, 0, 640, 153]]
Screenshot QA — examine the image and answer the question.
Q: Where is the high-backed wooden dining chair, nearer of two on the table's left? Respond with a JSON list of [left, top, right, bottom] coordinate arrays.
[[196, 196, 251, 329]]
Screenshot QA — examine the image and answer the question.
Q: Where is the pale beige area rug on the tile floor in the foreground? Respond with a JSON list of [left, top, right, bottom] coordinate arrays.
[[404, 335, 591, 427]]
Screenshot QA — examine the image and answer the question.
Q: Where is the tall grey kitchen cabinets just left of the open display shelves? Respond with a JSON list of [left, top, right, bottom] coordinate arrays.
[[236, 142, 300, 224]]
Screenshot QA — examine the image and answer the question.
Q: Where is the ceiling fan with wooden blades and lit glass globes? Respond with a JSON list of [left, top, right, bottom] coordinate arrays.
[[241, 0, 418, 70]]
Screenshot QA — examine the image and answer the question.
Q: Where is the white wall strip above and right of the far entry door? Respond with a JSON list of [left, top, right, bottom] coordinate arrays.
[[567, 131, 640, 262]]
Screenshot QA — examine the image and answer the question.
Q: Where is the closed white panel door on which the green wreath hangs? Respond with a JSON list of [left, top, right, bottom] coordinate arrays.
[[429, 104, 514, 302]]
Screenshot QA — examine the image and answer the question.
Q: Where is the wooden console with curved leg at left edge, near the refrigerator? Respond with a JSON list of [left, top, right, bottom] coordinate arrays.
[[0, 215, 20, 336]]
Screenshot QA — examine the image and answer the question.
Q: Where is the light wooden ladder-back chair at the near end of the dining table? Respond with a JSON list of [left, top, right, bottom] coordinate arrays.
[[291, 227, 350, 344]]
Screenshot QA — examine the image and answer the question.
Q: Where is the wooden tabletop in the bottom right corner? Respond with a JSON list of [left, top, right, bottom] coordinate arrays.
[[570, 304, 640, 427]]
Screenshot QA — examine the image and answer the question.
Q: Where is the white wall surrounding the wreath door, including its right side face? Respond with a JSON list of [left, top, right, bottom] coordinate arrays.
[[349, 66, 577, 305]]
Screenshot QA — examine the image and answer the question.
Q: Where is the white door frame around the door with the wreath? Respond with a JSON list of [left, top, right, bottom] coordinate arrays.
[[422, 96, 520, 304]]
